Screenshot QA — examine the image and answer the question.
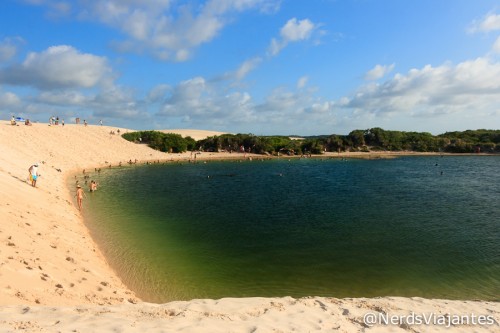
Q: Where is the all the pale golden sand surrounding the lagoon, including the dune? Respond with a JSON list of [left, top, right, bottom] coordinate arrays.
[[0, 121, 500, 332]]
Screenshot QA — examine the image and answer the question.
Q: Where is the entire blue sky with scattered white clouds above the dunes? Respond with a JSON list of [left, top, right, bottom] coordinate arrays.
[[0, 0, 500, 135]]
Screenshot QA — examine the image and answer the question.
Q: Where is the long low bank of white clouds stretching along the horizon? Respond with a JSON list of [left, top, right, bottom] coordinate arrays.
[[21, 52, 500, 134]]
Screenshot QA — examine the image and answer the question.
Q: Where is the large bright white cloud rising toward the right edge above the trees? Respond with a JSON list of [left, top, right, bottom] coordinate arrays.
[[343, 58, 500, 116]]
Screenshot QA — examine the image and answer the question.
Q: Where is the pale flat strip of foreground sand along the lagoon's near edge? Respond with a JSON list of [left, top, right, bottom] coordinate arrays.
[[0, 297, 499, 332]]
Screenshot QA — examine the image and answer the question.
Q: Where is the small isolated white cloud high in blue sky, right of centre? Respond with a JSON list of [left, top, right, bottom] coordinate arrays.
[[269, 18, 316, 56]]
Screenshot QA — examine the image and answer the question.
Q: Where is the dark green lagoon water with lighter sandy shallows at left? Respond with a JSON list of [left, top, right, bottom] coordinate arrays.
[[84, 156, 500, 302]]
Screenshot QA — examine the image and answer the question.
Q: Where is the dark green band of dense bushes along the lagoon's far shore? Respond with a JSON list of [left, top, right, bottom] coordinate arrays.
[[123, 128, 500, 155]]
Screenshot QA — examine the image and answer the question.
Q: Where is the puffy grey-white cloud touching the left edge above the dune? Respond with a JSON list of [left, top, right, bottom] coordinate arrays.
[[0, 45, 111, 90]]
